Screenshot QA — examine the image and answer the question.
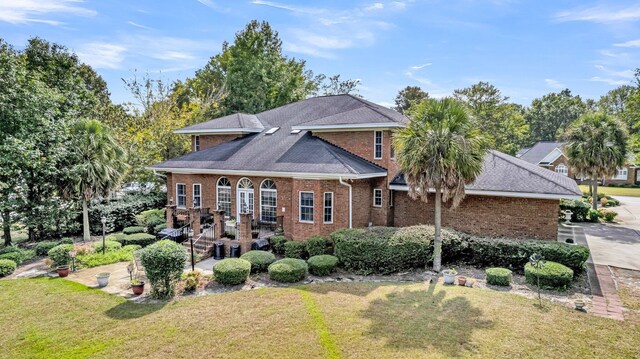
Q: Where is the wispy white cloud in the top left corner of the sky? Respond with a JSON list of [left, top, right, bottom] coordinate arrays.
[[0, 0, 97, 26]]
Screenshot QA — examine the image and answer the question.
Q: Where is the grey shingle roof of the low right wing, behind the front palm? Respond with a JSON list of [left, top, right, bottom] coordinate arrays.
[[391, 151, 582, 196]]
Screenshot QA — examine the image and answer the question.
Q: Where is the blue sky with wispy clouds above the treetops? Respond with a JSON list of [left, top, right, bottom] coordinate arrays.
[[0, 0, 640, 106]]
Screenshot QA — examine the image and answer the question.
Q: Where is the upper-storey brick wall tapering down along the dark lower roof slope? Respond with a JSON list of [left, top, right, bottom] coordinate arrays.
[[313, 130, 398, 181]]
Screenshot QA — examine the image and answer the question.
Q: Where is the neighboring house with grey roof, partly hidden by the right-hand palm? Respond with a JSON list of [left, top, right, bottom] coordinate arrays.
[[516, 141, 640, 184]]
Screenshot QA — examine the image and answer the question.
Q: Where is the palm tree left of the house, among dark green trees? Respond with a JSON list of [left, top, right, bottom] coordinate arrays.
[[71, 119, 125, 241]]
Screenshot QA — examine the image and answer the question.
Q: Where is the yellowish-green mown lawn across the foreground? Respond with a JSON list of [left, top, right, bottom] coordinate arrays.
[[0, 278, 640, 359]]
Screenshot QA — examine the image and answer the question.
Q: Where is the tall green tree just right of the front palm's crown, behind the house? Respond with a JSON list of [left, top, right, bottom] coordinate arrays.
[[453, 82, 529, 155]]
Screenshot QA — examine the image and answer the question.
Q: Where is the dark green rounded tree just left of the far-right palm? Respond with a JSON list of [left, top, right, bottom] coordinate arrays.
[[525, 89, 586, 142]]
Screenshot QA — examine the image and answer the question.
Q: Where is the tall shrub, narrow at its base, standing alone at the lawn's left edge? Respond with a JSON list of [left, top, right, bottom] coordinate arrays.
[[139, 240, 187, 299]]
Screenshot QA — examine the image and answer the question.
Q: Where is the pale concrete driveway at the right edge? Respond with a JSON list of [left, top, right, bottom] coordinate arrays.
[[581, 196, 640, 270]]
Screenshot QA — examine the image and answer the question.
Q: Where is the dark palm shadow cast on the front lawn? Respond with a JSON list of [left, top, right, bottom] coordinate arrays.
[[361, 284, 493, 357]]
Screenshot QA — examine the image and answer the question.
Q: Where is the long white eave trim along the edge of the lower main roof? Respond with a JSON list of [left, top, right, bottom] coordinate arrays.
[[146, 167, 387, 180]]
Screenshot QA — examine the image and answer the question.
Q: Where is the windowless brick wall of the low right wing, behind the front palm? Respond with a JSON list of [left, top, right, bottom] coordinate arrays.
[[394, 191, 559, 240]]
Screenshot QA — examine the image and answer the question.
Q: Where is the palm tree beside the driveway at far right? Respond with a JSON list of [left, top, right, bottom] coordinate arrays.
[[565, 112, 627, 210]]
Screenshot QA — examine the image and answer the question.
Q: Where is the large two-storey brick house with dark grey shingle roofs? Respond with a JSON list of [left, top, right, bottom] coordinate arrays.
[[151, 95, 580, 240]]
